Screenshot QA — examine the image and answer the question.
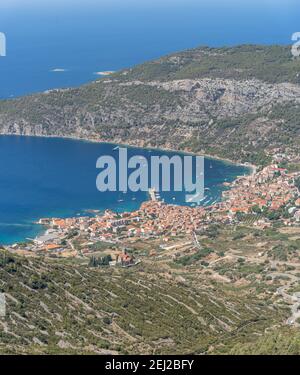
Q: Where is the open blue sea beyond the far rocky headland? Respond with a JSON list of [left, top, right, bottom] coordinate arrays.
[[0, 0, 300, 98]]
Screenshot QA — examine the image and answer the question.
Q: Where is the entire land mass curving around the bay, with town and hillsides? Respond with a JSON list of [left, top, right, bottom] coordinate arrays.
[[0, 45, 300, 354]]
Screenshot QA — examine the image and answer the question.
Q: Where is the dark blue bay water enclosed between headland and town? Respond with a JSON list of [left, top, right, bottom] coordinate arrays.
[[0, 136, 249, 244]]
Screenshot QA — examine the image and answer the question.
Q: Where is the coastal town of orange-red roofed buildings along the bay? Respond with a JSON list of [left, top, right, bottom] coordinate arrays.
[[7, 164, 300, 267]]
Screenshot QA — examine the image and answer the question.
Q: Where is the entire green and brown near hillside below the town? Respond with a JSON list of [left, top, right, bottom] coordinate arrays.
[[0, 225, 300, 354]]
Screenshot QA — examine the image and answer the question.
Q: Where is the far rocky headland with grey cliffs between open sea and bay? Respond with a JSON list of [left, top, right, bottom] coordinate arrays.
[[0, 45, 300, 163]]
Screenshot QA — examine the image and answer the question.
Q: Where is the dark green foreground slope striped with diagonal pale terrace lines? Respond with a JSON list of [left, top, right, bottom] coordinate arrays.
[[0, 251, 288, 354]]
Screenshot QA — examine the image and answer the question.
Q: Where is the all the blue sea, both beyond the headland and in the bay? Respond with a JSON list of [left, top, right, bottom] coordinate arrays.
[[0, 0, 300, 244]]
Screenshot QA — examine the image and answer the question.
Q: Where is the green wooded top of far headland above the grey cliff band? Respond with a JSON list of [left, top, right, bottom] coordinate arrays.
[[115, 45, 300, 84]]
